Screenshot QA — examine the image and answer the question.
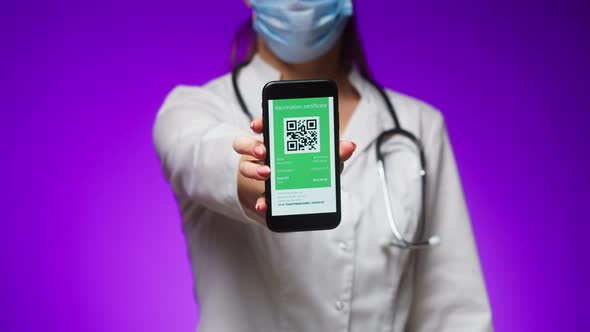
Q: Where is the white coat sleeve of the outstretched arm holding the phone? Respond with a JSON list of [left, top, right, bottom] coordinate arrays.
[[153, 86, 255, 223]]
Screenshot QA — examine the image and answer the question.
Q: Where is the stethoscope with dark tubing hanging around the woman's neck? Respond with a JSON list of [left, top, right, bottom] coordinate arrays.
[[231, 62, 440, 249]]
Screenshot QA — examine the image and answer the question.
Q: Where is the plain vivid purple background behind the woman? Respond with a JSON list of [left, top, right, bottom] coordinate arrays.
[[0, 0, 590, 331]]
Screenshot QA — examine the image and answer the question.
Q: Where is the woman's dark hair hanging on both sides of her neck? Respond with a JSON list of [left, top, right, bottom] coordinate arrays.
[[230, 16, 371, 79]]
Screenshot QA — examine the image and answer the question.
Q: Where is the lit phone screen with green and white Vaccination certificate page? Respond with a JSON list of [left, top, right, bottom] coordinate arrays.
[[268, 97, 336, 216]]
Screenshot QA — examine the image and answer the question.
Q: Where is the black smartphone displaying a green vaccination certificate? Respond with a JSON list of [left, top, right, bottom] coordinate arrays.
[[262, 80, 341, 232]]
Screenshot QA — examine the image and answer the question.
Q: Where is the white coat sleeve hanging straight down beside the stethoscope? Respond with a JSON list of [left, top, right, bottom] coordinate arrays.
[[408, 112, 493, 332]]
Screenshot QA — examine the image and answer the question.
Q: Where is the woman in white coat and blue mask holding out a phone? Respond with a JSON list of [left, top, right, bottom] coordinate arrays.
[[154, 0, 492, 332]]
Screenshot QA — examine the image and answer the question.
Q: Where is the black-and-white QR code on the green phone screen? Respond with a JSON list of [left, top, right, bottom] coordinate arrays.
[[284, 116, 320, 154]]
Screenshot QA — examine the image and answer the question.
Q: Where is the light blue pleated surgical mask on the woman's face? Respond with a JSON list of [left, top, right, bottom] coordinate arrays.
[[250, 0, 352, 63]]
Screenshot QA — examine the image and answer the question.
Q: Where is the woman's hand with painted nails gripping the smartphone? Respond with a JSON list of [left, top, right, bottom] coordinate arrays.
[[233, 118, 356, 224]]
